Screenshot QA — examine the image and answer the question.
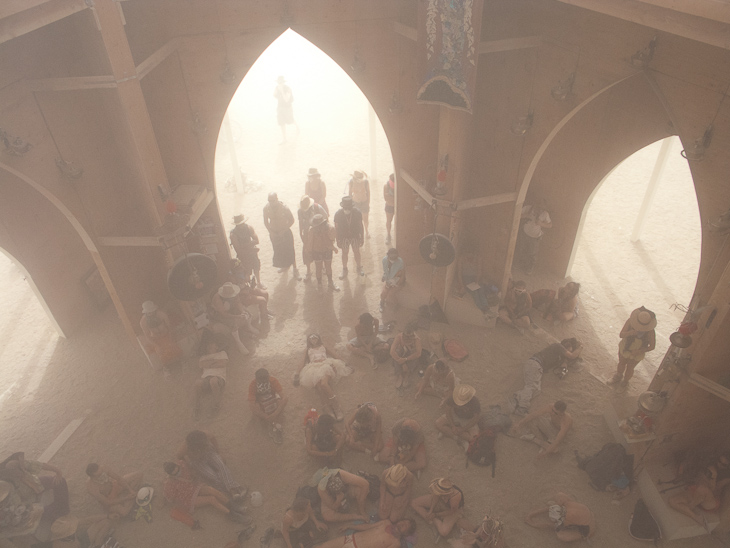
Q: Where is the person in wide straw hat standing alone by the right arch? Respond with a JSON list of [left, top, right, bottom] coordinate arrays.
[[608, 306, 656, 386]]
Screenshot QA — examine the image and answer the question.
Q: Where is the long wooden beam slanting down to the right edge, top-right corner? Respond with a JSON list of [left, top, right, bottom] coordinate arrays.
[[558, 0, 730, 49]]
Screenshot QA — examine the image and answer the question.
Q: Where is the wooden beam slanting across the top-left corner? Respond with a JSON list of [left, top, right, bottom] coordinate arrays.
[[0, 0, 89, 44]]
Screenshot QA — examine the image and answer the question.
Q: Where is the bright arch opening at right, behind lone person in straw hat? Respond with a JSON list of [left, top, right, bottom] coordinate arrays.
[[566, 137, 702, 383]]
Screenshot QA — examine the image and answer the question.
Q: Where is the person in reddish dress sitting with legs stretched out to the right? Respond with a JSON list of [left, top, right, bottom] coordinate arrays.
[[162, 460, 251, 523]]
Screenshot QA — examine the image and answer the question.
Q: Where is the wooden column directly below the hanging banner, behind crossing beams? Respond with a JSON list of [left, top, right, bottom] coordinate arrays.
[[431, 107, 474, 307]]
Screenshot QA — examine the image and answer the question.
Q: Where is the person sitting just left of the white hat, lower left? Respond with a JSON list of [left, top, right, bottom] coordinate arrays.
[[86, 462, 142, 519]]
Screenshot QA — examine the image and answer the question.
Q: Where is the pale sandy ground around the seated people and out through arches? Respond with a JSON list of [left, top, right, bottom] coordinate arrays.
[[0, 39, 710, 548]]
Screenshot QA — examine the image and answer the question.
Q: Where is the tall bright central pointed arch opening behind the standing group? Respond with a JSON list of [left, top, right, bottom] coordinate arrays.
[[210, 29, 395, 308]]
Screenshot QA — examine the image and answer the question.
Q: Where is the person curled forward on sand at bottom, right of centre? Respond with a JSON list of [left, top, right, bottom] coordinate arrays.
[[525, 493, 596, 542]]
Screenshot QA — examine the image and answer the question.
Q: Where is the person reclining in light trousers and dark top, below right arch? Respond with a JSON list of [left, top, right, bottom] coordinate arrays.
[[509, 337, 583, 415]]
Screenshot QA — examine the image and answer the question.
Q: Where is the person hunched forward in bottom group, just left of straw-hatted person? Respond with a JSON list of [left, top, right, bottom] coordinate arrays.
[[315, 468, 370, 522]]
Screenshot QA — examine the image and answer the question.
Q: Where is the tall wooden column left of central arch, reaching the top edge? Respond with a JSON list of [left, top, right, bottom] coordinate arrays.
[[93, 0, 169, 227]]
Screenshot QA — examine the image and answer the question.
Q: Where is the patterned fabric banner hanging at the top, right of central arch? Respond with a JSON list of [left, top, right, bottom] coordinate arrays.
[[416, 0, 484, 112]]
